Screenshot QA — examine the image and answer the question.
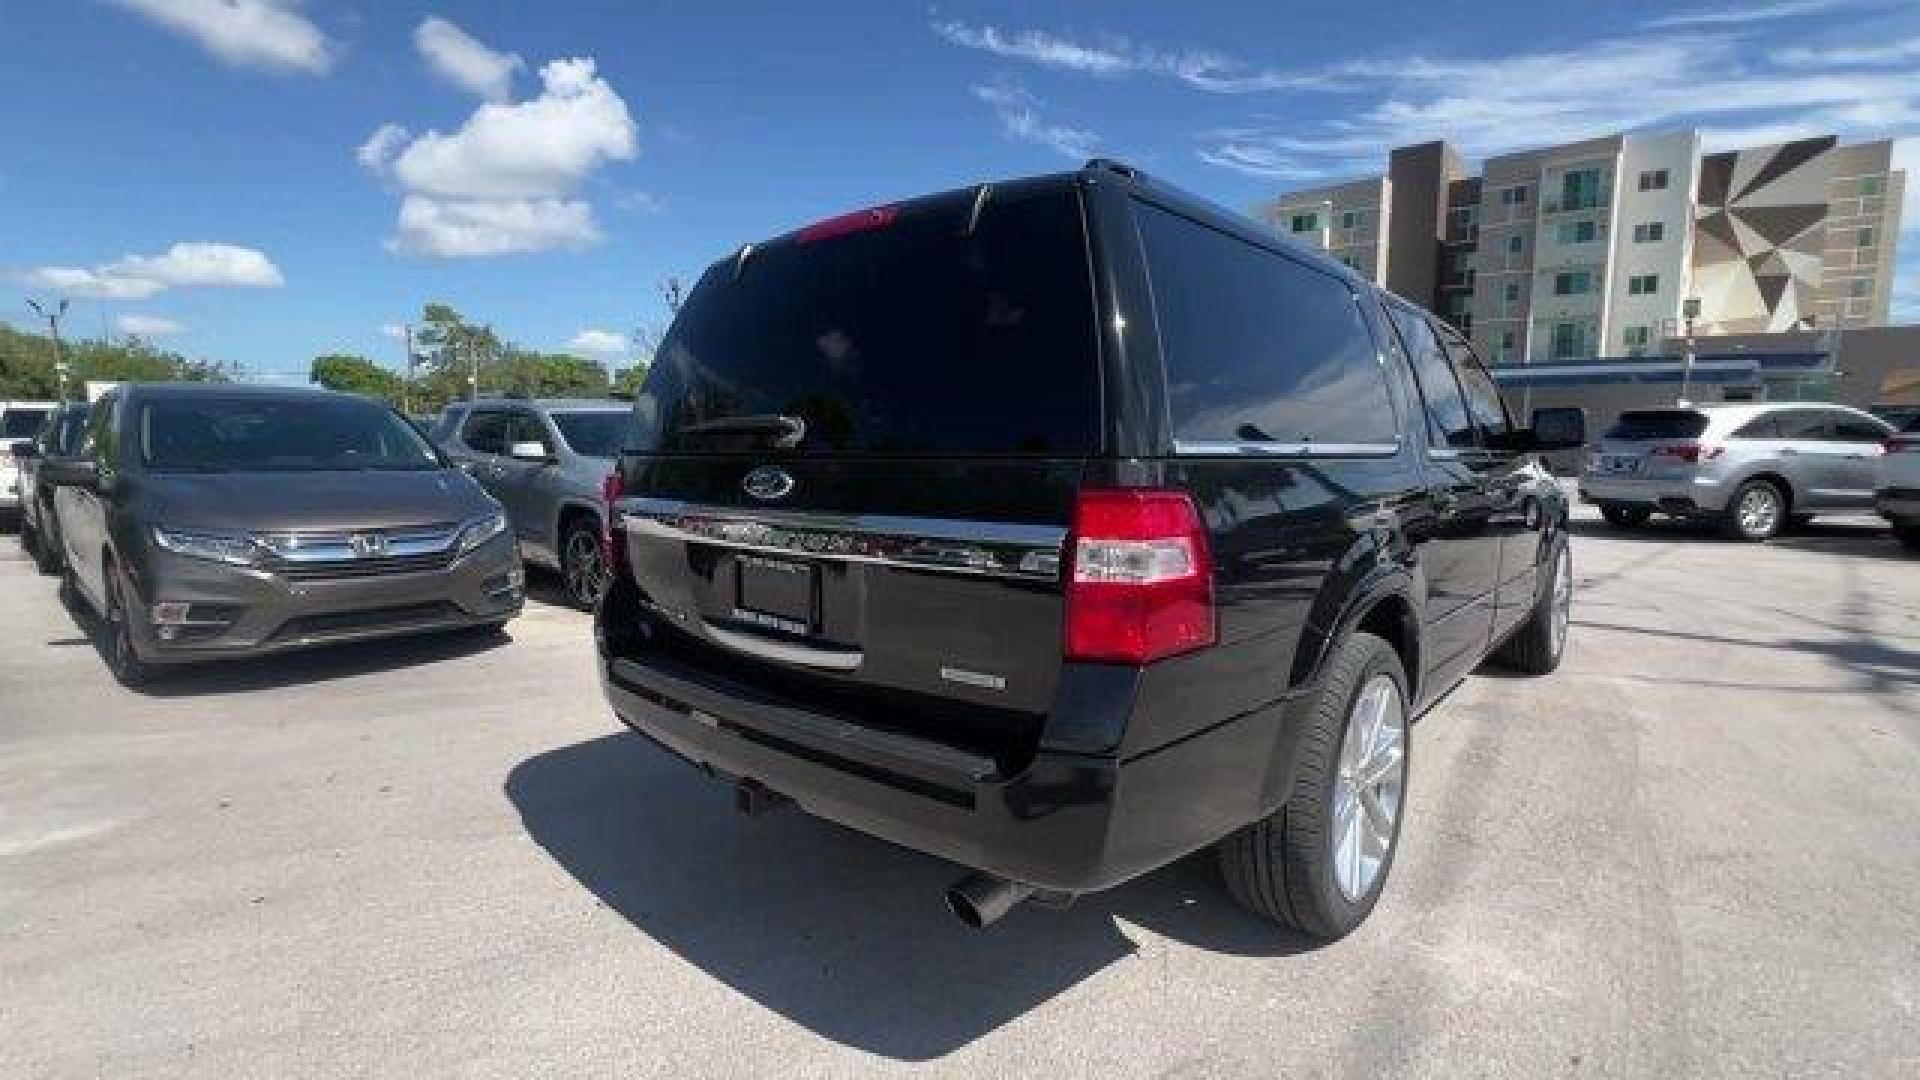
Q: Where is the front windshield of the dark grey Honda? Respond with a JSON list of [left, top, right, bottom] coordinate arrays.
[[138, 396, 440, 473]]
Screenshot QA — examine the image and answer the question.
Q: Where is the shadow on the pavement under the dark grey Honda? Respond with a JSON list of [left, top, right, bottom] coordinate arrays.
[[48, 576, 511, 698]]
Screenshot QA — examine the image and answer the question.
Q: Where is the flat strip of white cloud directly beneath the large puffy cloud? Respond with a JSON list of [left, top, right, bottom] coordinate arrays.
[[390, 194, 599, 259]]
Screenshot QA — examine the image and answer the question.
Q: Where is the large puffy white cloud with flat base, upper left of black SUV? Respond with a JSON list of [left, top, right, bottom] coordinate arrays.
[[366, 39, 639, 258]]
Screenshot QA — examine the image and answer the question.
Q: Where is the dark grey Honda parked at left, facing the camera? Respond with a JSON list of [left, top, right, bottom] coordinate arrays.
[[42, 384, 522, 684]]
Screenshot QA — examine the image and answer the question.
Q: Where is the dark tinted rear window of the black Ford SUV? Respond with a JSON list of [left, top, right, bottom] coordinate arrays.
[[632, 188, 1098, 454]]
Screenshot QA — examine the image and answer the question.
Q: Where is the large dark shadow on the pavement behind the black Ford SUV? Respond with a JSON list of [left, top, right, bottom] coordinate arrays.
[[505, 732, 1311, 1061]]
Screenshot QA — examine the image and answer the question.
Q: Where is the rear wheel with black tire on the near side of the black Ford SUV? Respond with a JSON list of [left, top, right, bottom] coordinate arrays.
[[1217, 632, 1411, 942]]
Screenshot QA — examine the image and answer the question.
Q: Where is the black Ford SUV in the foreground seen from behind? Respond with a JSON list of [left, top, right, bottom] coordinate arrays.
[[597, 161, 1584, 938]]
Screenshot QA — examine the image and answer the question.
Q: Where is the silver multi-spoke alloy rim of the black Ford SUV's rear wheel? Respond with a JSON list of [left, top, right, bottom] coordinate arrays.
[[1329, 675, 1407, 903]]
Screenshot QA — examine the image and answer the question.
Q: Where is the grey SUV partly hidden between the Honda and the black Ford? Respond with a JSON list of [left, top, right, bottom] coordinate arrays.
[[432, 398, 632, 609]]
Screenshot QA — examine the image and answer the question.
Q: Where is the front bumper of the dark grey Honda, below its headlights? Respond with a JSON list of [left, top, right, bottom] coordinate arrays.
[[132, 534, 524, 663]]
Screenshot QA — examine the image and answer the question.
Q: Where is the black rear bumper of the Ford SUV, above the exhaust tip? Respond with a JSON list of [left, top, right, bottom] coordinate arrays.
[[601, 651, 1296, 894]]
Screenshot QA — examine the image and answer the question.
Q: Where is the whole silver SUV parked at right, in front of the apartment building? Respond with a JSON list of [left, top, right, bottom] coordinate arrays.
[[1580, 402, 1893, 540]]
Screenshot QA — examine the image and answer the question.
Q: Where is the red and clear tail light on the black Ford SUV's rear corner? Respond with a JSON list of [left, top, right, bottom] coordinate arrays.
[[1066, 488, 1215, 665]]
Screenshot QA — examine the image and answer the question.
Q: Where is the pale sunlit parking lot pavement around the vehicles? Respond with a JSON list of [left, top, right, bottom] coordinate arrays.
[[0, 511, 1920, 1078]]
